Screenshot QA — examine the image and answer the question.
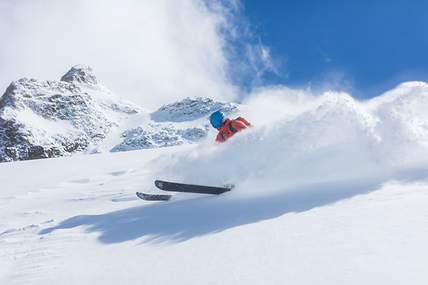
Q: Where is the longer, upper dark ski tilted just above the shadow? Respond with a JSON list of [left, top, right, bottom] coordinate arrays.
[[155, 180, 234, 195]]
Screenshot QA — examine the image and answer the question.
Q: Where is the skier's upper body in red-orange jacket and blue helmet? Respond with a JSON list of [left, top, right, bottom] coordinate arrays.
[[210, 111, 251, 143]]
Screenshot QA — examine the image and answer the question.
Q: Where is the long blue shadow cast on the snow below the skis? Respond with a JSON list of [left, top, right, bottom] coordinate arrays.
[[40, 179, 380, 244]]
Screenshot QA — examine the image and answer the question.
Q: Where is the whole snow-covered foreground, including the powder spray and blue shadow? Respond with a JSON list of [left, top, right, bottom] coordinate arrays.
[[0, 82, 428, 285]]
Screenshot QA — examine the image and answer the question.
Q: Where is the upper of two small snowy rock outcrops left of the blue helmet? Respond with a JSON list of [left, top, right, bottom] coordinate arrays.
[[151, 97, 238, 122]]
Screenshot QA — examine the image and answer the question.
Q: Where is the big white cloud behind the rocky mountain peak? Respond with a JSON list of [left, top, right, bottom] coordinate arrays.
[[0, 0, 270, 108]]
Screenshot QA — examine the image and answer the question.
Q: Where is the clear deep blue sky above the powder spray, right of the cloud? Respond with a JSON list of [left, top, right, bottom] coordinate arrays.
[[243, 0, 428, 98]]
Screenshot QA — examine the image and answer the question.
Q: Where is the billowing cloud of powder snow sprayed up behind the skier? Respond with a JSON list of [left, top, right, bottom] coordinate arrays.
[[157, 82, 428, 192]]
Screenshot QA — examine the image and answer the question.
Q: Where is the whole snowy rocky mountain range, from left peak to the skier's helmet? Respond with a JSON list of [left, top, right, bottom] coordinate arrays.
[[0, 66, 237, 162]]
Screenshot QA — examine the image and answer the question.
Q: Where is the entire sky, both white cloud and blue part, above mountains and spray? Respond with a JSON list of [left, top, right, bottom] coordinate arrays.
[[0, 0, 428, 103]]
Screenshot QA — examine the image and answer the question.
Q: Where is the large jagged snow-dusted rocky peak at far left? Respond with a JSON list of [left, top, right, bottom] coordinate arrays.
[[0, 66, 138, 161]]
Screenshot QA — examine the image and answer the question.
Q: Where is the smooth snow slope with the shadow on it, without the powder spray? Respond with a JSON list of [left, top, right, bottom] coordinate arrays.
[[0, 146, 428, 284]]
